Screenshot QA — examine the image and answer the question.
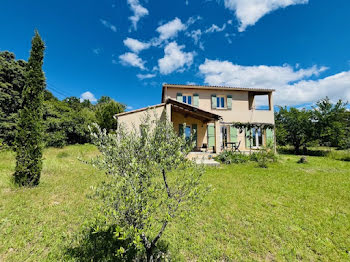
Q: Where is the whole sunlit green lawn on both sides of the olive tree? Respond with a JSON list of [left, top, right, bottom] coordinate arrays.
[[0, 145, 350, 261]]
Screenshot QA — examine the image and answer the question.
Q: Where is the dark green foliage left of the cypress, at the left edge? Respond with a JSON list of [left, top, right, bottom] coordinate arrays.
[[0, 51, 26, 145]]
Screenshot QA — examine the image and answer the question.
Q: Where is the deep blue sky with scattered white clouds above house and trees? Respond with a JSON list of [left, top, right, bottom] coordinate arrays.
[[0, 0, 350, 109]]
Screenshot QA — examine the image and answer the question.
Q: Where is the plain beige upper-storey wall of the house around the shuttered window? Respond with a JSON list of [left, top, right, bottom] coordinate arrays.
[[166, 88, 275, 124]]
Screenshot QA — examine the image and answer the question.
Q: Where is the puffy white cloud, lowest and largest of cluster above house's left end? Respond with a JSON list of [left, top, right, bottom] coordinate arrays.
[[158, 42, 194, 75]]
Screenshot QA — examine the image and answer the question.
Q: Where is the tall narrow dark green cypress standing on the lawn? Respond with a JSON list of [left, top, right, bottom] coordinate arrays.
[[14, 31, 45, 186]]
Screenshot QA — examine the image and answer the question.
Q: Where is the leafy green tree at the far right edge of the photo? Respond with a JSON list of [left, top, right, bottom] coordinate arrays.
[[313, 97, 348, 147]]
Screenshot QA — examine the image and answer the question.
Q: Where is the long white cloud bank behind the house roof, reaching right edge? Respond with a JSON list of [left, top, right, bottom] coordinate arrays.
[[199, 59, 350, 105]]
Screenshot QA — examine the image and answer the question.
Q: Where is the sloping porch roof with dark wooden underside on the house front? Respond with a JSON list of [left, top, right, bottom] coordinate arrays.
[[165, 98, 222, 122]]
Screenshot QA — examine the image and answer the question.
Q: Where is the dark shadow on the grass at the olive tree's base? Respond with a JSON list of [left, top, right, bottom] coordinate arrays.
[[65, 225, 168, 261]]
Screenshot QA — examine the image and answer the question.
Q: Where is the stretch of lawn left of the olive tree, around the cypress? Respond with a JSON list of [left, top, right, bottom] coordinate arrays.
[[0, 145, 104, 261]]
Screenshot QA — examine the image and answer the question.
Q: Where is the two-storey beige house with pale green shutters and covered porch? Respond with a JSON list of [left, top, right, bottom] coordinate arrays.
[[116, 84, 275, 153]]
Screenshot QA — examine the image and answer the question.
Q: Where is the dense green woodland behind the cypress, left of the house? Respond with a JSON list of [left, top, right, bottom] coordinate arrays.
[[0, 51, 125, 147]]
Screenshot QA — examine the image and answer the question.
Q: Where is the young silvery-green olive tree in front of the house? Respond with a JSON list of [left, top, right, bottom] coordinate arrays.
[[89, 114, 206, 261]]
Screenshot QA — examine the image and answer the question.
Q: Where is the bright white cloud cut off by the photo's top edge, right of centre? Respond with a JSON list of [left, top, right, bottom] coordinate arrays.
[[224, 0, 309, 32]]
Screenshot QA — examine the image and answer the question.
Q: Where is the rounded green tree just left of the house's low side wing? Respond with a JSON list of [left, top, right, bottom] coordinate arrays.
[[96, 99, 125, 131]]
